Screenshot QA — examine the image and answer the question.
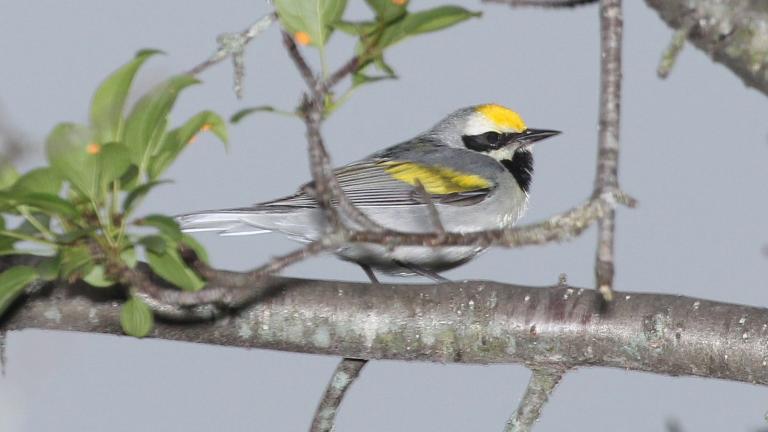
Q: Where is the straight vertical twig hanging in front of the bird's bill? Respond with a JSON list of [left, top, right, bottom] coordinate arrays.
[[594, 0, 623, 301]]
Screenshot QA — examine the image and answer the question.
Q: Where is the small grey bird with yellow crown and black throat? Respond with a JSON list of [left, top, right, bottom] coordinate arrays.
[[176, 103, 560, 281]]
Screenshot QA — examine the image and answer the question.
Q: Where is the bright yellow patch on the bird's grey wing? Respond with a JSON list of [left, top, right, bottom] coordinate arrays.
[[381, 161, 492, 195]]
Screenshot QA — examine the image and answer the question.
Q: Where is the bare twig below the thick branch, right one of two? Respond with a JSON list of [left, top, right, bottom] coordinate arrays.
[[504, 368, 564, 432]]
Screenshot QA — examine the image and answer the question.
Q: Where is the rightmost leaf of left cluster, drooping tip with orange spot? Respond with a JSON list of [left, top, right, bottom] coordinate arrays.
[[147, 111, 228, 179]]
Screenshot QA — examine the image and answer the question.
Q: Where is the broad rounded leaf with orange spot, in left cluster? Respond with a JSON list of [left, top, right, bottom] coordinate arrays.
[[46, 123, 101, 198]]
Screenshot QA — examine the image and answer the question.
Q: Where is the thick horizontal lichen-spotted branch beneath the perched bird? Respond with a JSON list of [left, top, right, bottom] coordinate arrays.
[[6, 278, 768, 385]]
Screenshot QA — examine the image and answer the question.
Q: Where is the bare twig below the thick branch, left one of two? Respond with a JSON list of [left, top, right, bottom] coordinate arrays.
[[309, 358, 368, 432]]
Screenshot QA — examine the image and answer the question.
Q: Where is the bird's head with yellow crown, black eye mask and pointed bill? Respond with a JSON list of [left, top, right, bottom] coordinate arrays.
[[428, 104, 560, 160]]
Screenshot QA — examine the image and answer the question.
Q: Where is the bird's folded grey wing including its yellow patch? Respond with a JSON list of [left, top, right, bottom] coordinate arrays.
[[261, 159, 495, 207]]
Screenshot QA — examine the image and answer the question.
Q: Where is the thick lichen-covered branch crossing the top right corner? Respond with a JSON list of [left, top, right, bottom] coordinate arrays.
[[646, 0, 768, 95]]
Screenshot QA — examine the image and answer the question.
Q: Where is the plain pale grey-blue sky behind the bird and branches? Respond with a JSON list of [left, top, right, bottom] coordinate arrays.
[[0, 0, 768, 432]]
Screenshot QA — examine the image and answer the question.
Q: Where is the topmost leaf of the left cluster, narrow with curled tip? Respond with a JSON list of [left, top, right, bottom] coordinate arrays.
[[91, 50, 160, 142]]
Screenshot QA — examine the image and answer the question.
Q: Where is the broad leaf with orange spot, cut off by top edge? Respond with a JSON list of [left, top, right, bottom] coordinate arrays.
[[274, 0, 347, 47]]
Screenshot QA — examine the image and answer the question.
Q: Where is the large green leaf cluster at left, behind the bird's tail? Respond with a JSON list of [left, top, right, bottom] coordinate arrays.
[[0, 50, 227, 336]]
